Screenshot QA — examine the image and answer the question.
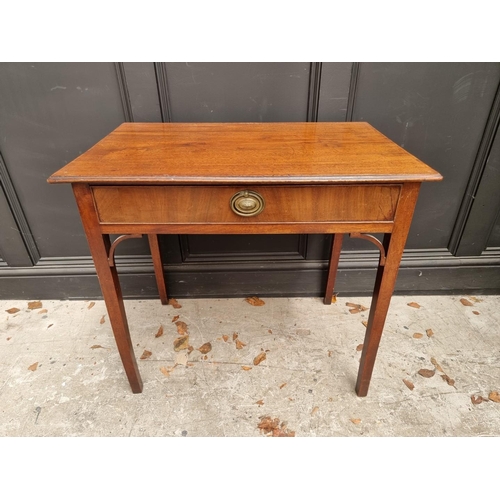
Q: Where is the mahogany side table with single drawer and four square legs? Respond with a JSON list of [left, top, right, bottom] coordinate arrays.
[[48, 123, 442, 396]]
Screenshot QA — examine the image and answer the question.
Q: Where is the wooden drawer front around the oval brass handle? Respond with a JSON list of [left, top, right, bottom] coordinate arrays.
[[92, 184, 400, 224]]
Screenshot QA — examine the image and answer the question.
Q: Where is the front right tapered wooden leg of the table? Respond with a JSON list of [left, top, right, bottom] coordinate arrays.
[[356, 184, 420, 396]]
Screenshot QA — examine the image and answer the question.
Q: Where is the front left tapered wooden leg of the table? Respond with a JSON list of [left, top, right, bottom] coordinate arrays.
[[73, 184, 142, 393]]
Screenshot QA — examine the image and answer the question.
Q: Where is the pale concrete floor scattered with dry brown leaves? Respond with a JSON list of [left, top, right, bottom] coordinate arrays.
[[0, 296, 500, 436]]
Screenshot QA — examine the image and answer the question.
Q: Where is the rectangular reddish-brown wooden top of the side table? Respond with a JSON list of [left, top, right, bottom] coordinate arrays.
[[48, 122, 442, 185]]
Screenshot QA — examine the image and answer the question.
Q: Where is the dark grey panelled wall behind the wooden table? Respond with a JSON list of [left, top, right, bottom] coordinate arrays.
[[0, 62, 500, 298]]
